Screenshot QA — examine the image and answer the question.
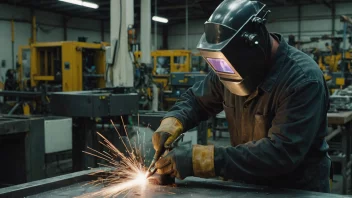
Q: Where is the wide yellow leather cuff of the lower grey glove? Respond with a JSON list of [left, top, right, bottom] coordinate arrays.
[[192, 145, 215, 178]]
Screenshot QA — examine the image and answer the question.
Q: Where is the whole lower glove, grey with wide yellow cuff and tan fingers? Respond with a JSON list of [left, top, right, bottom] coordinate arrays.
[[155, 145, 215, 179]]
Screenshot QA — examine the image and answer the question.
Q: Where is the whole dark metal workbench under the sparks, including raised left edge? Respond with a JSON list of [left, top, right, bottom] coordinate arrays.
[[0, 170, 352, 198]]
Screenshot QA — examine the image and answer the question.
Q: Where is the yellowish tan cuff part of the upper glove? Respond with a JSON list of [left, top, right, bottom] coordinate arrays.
[[155, 117, 183, 136]]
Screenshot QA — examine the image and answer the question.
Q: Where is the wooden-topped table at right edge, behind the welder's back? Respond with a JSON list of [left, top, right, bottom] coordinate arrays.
[[326, 111, 352, 194]]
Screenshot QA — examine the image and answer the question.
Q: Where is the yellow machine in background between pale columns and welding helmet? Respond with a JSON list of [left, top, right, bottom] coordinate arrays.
[[134, 50, 209, 110]]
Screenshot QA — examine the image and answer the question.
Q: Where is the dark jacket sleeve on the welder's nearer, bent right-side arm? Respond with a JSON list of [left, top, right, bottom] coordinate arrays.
[[214, 81, 328, 179]]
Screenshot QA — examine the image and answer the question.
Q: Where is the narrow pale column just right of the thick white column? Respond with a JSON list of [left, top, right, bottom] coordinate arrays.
[[140, 0, 152, 65]]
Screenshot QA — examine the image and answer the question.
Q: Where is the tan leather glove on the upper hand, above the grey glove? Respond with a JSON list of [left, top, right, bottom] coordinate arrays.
[[152, 117, 183, 160]]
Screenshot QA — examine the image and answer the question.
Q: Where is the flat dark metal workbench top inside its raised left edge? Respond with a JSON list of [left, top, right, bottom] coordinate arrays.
[[26, 178, 351, 198]]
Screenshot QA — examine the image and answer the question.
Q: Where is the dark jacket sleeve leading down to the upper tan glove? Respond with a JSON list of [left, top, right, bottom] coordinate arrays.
[[164, 71, 224, 131]]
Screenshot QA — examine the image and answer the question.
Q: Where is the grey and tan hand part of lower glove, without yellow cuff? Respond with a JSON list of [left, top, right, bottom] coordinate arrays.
[[155, 144, 193, 179]]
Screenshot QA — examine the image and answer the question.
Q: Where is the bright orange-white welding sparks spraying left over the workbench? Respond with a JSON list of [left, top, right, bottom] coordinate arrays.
[[79, 118, 149, 197]]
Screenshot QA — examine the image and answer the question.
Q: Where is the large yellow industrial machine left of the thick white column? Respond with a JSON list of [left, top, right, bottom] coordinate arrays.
[[0, 41, 109, 115]]
